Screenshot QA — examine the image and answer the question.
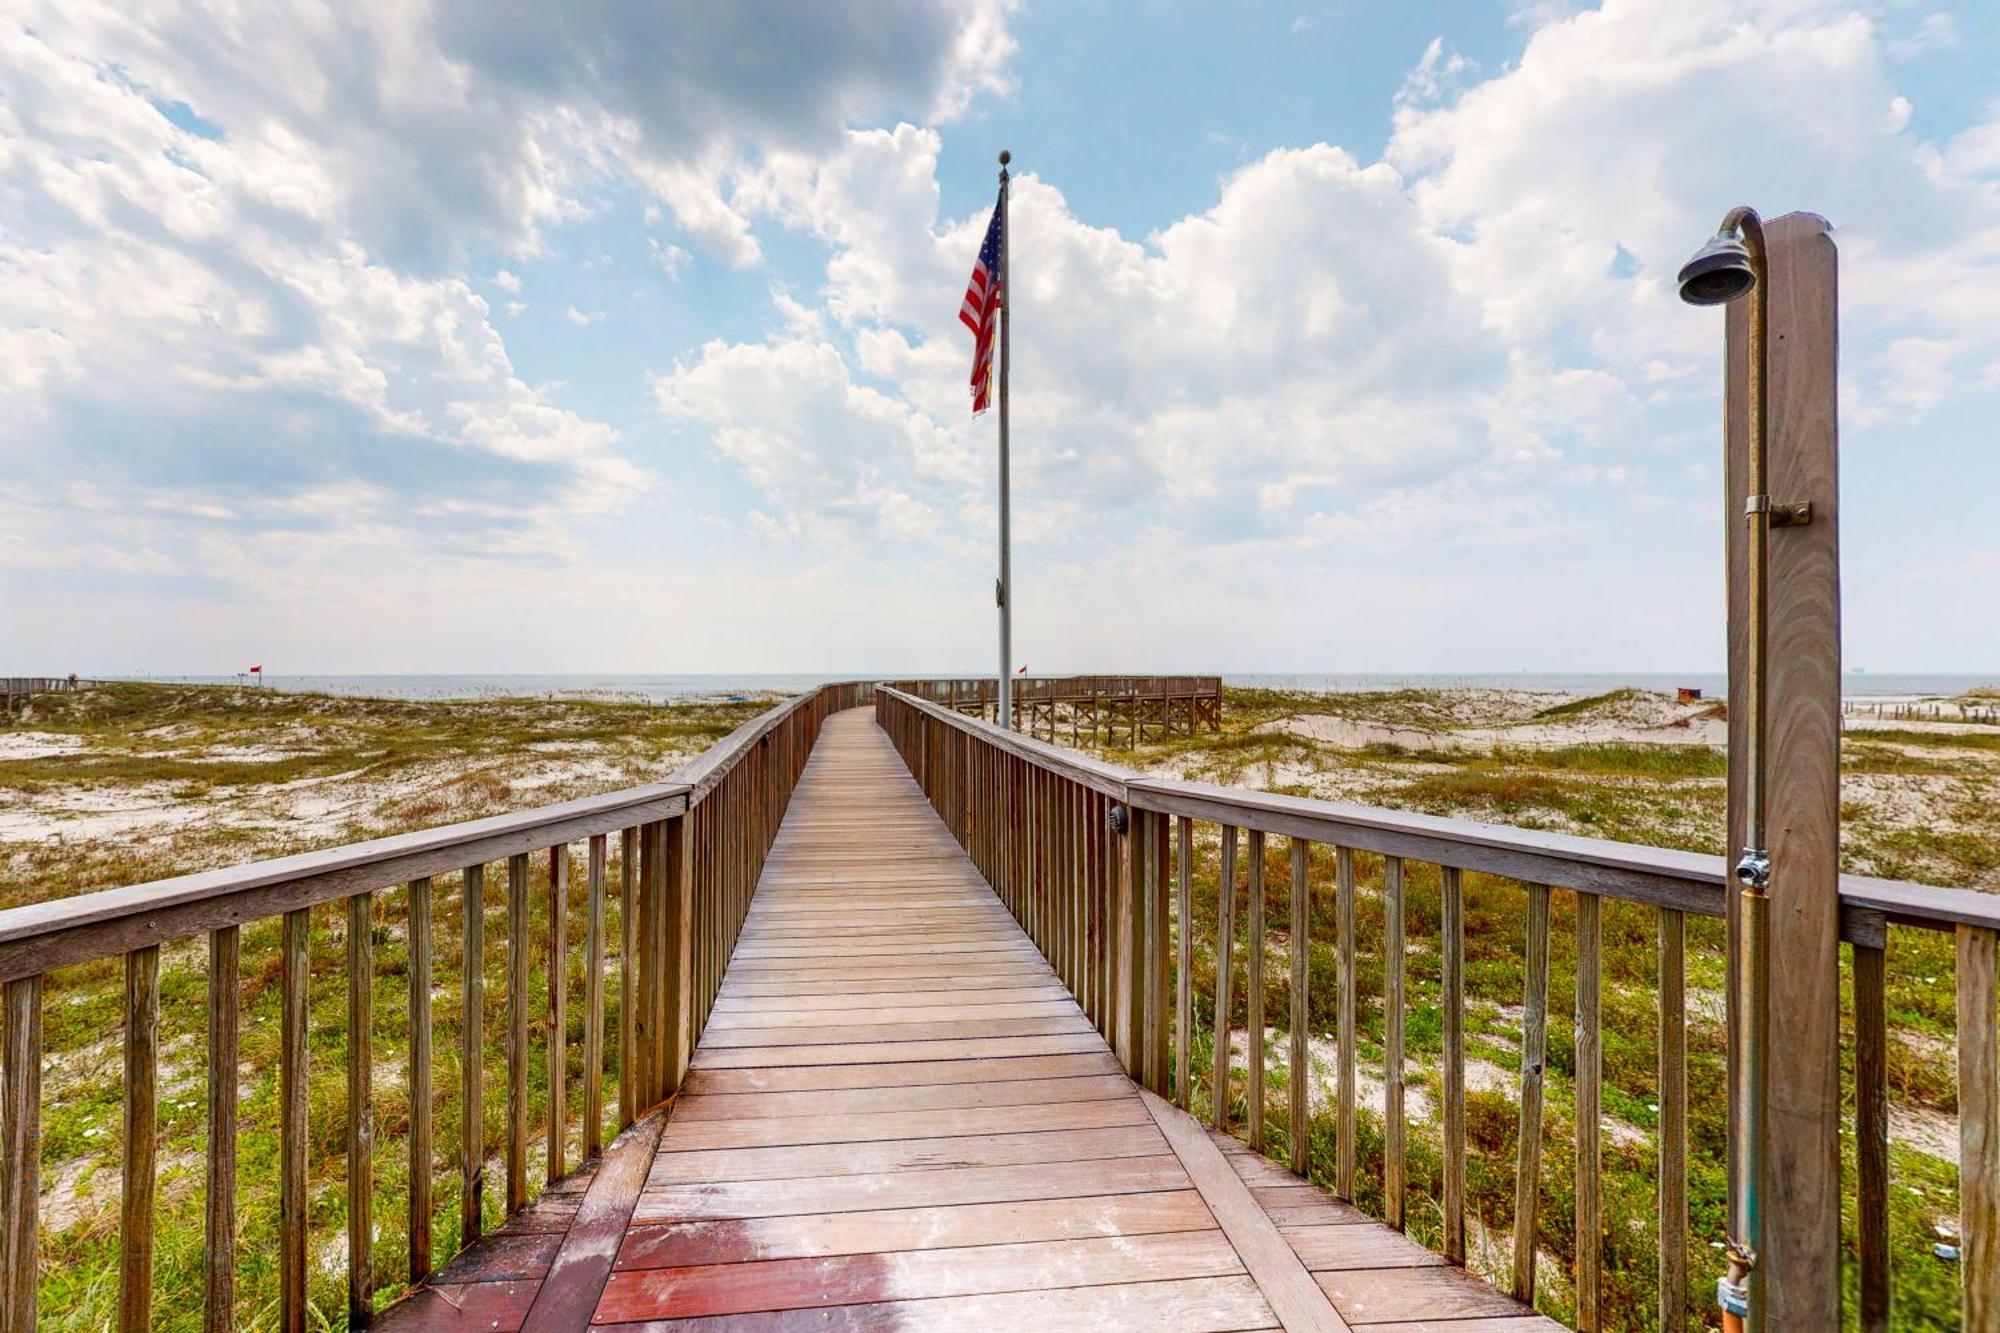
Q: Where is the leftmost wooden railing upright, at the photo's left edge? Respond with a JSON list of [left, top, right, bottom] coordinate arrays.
[[0, 964, 42, 1333]]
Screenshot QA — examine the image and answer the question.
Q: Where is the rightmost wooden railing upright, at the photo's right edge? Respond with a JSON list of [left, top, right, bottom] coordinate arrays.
[[1958, 925, 2000, 1333]]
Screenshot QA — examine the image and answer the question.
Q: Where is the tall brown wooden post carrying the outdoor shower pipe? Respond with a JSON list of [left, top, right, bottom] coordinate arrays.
[[1724, 214, 1840, 1329]]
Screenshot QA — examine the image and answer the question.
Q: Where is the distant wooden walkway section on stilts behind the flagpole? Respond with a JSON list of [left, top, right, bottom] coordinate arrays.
[[886, 677, 1222, 745]]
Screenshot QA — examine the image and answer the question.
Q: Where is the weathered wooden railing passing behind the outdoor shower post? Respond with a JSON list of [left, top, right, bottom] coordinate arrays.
[[876, 689, 2000, 1329]]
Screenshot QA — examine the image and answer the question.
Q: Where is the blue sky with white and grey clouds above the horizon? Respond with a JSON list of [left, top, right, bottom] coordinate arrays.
[[0, 0, 2000, 673]]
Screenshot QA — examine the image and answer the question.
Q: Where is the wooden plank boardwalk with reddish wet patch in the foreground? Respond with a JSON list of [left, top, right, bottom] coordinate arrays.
[[380, 711, 1560, 1333]]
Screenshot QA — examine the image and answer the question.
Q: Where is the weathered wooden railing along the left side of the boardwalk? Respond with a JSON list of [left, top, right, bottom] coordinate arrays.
[[0, 683, 872, 1333]]
